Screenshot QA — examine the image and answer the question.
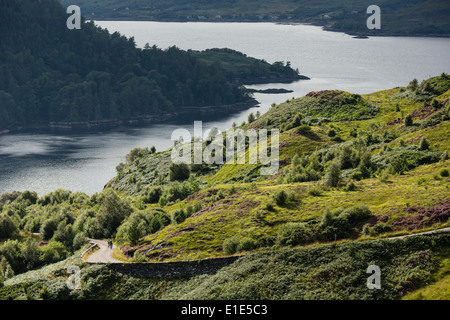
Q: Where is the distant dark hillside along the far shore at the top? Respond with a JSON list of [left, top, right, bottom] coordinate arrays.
[[60, 0, 450, 36]]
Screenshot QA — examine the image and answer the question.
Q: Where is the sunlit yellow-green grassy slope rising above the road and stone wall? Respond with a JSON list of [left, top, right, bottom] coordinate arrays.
[[111, 75, 450, 260]]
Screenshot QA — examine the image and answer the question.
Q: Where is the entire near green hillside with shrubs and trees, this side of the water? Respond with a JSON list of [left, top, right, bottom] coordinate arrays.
[[0, 74, 450, 299]]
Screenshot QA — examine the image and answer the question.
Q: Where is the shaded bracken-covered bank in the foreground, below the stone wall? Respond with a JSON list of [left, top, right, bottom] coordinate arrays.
[[0, 235, 450, 300]]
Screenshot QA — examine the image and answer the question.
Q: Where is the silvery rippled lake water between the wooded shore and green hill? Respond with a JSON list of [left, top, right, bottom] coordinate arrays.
[[0, 21, 450, 195]]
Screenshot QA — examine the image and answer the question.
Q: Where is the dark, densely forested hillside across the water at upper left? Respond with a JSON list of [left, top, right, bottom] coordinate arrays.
[[0, 0, 302, 130]]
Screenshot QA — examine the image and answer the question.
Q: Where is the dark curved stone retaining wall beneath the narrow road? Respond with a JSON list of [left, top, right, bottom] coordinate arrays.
[[90, 256, 241, 278]]
